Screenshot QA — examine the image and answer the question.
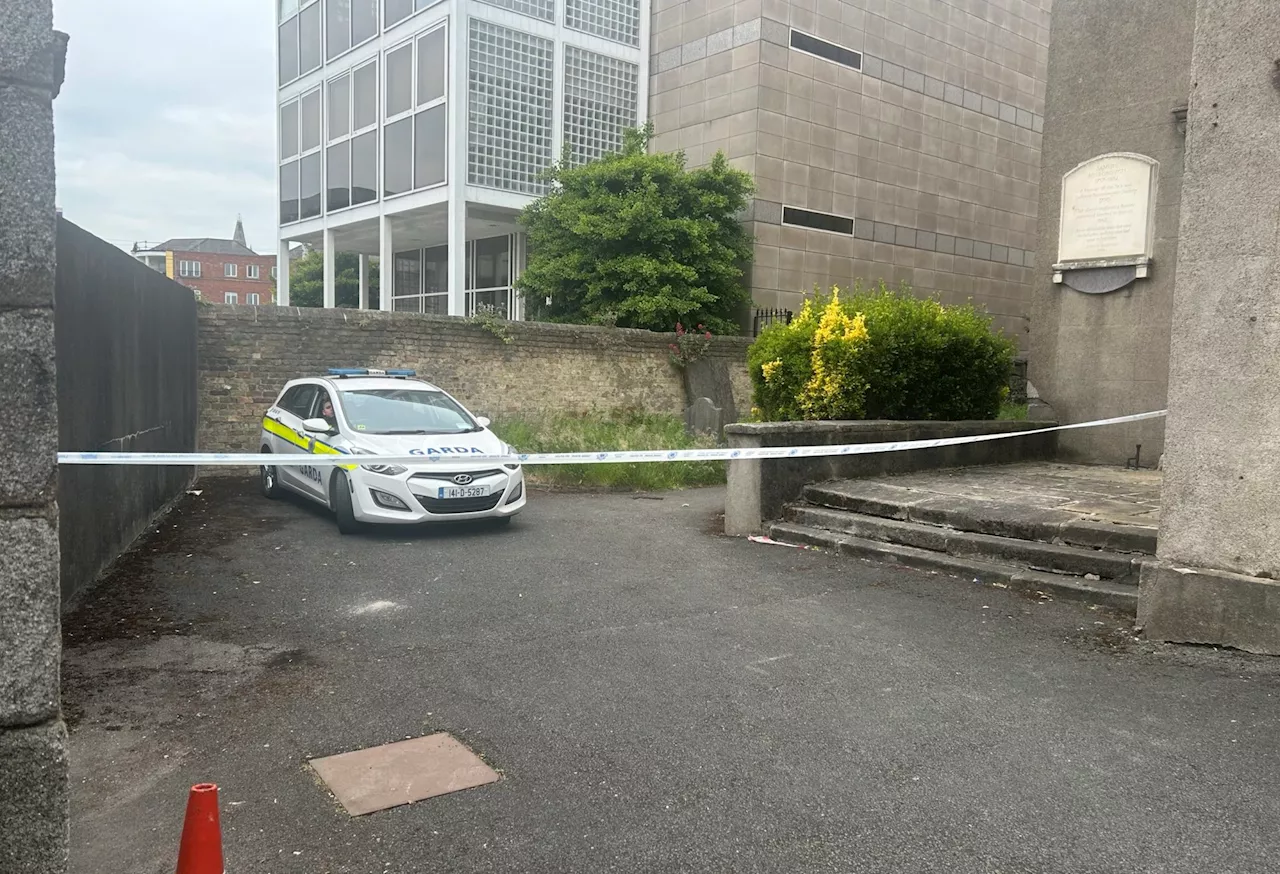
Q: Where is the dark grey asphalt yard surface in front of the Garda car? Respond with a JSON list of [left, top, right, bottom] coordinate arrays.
[[64, 480, 1280, 874]]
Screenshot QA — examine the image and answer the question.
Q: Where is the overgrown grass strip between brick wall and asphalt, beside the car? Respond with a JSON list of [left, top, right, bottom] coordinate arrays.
[[493, 413, 724, 491]]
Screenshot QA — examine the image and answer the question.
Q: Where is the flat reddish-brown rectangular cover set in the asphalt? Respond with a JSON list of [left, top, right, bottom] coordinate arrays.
[[310, 732, 498, 816]]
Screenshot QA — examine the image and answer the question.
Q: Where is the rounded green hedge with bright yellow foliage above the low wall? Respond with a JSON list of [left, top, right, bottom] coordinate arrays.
[[748, 283, 1015, 421]]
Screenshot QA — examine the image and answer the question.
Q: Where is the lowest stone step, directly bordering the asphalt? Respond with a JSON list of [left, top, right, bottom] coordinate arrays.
[[769, 522, 1138, 617]]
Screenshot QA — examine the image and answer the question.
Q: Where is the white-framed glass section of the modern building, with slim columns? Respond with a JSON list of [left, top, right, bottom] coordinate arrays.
[[278, 0, 649, 317]]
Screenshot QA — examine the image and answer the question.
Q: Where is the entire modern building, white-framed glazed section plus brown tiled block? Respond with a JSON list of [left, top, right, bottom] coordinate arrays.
[[279, 0, 1051, 338]]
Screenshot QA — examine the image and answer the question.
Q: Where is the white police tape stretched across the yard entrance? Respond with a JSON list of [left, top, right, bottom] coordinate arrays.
[[58, 409, 1167, 467]]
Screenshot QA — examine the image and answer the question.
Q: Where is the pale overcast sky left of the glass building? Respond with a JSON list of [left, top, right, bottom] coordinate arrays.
[[53, 0, 275, 253]]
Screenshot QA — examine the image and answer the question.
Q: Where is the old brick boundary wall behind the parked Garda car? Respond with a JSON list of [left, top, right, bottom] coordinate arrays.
[[198, 305, 751, 455]]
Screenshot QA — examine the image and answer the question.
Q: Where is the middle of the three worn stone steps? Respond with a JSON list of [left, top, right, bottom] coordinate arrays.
[[786, 504, 1142, 581]]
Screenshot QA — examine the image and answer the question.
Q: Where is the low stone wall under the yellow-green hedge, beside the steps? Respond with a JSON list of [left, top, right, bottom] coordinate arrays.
[[724, 420, 1057, 535]]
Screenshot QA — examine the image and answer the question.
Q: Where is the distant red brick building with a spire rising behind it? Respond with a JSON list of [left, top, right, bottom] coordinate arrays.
[[132, 219, 275, 306]]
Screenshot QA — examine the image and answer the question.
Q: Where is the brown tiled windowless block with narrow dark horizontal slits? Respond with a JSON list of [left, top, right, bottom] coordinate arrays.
[[650, 0, 1051, 343]]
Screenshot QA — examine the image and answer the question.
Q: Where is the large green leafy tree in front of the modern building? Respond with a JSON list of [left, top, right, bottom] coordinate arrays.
[[520, 124, 753, 334]]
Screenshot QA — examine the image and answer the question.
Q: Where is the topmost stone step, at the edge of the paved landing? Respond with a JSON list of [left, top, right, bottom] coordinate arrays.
[[804, 480, 1157, 555]]
